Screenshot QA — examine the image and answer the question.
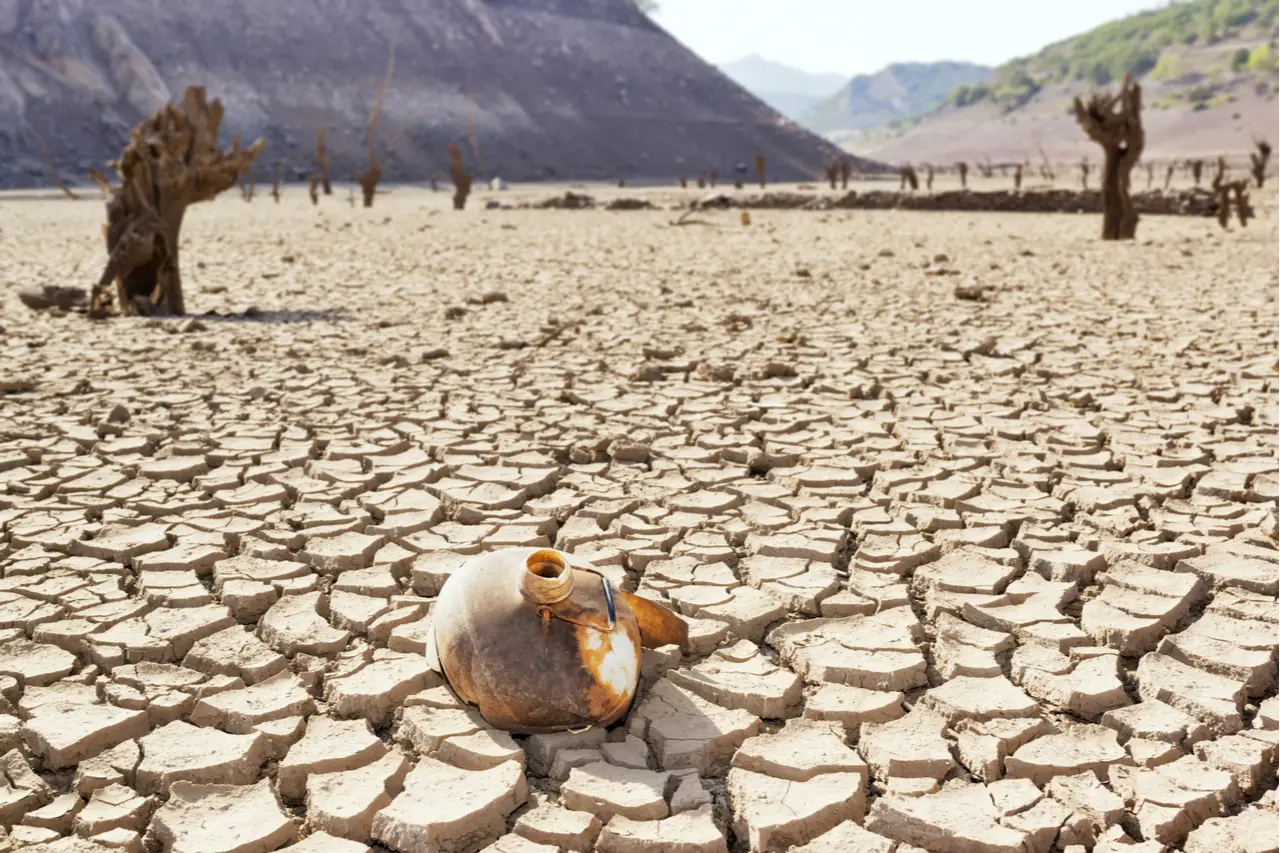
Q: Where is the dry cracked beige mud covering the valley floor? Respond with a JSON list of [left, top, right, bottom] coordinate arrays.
[[0, 187, 1280, 853]]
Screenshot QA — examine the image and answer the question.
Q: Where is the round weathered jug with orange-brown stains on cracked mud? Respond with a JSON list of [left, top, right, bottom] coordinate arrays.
[[426, 548, 689, 734]]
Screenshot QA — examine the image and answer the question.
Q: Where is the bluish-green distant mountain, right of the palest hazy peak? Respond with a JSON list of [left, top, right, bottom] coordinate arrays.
[[803, 61, 992, 133]]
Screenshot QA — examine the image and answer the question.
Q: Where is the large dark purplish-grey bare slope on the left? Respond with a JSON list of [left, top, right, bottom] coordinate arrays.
[[0, 0, 864, 187]]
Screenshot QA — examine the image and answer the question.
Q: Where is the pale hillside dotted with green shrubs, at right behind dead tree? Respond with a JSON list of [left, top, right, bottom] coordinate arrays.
[[846, 0, 1280, 163]]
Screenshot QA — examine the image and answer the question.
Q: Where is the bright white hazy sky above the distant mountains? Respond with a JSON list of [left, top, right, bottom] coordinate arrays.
[[654, 0, 1165, 76]]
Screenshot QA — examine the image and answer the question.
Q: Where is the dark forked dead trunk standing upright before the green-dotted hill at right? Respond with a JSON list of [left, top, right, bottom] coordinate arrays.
[[1075, 74, 1147, 240]]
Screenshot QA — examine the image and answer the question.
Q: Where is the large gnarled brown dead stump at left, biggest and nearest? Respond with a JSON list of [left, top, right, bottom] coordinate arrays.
[[90, 86, 266, 316]]
